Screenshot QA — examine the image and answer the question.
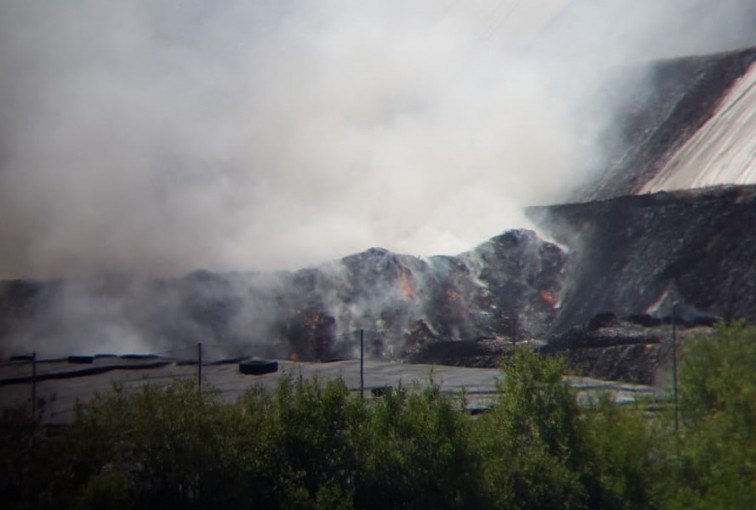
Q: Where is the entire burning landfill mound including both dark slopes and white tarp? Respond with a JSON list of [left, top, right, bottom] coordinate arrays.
[[0, 2, 756, 382]]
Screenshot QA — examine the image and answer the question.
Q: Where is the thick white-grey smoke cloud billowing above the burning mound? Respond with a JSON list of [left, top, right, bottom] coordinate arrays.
[[0, 0, 751, 278]]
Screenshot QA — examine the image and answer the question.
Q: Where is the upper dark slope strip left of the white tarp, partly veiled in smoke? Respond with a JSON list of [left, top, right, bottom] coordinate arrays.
[[575, 48, 756, 202]]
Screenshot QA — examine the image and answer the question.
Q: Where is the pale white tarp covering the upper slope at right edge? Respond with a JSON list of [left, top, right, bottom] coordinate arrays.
[[640, 64, 756, 193]]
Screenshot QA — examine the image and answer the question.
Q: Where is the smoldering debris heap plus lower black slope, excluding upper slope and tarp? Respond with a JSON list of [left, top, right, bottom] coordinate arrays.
[[0, 186, 756, 383]]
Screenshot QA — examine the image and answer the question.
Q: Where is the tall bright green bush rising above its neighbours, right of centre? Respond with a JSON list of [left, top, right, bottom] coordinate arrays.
[[477, 348, 585, 509]]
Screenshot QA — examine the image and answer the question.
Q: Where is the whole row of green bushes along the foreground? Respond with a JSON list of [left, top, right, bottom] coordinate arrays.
[[0, 323, 756, 509]]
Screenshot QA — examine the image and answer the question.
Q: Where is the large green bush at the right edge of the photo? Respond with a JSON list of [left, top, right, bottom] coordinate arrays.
[[670, 322, 756, 508]]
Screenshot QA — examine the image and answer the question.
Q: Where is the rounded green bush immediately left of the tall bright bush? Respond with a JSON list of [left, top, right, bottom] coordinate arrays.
[[356, 381, 481, 509]]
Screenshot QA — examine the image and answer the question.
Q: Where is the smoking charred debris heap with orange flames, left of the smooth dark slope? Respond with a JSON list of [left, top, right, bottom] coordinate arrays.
[[0, 231, 566, 360]]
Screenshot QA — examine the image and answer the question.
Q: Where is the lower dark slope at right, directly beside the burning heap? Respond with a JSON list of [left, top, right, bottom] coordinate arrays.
[[528, 186, 756, 333]]
